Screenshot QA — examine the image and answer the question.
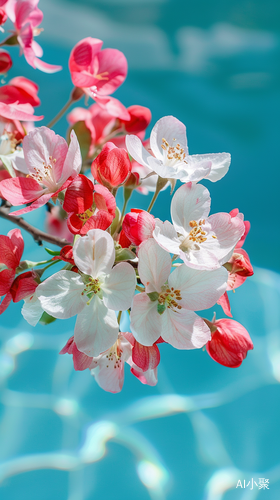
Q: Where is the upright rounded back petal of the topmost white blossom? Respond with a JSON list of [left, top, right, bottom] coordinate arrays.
[[150, 116, 188, 160]]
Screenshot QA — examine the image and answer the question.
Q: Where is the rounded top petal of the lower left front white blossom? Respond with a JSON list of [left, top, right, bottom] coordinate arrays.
[[73, 229, 115, 278]]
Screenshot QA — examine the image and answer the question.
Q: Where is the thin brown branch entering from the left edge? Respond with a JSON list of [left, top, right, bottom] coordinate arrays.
[[0, 201, 71, 248]]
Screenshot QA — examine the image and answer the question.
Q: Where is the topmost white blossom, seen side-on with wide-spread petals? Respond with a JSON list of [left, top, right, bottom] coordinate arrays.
[[126, 116, 230, 182]]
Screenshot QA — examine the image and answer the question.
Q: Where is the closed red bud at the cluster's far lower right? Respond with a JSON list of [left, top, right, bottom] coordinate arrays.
[[206, 319, 254, 368]]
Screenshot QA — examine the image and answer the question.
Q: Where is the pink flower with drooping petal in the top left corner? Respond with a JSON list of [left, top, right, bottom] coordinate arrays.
[[5, 0, 62, 73]]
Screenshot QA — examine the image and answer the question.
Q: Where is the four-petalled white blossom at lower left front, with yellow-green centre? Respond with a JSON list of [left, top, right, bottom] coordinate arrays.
[[36, 229, 136, 356]]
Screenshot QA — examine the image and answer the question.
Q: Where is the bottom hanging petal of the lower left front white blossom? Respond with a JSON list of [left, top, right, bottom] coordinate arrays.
[[74, 296, 119, 357]]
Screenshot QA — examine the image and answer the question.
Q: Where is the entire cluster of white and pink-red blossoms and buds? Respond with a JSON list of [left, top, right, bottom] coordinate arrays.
[[0, 0, 253, 392]]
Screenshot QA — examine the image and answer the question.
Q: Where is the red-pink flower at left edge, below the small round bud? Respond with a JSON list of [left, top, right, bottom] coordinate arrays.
[[0, 76, 41, 106]]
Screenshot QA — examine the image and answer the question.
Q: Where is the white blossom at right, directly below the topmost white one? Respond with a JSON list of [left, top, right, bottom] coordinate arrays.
[[153, 182, 245, 269]]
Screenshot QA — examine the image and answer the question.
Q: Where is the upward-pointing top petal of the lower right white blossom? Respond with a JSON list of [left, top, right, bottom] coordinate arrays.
[[138, 238, 171, 293]]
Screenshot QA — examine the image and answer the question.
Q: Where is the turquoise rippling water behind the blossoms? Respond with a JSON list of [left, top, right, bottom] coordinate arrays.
[[0, 0, 280, 500]]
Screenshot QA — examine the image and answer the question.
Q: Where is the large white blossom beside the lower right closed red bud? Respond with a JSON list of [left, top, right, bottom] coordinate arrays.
[[130, 238, 227, 349]]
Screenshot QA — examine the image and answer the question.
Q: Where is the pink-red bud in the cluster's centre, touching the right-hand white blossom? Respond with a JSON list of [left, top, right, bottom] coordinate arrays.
[[122, 208, 155, 246]]
